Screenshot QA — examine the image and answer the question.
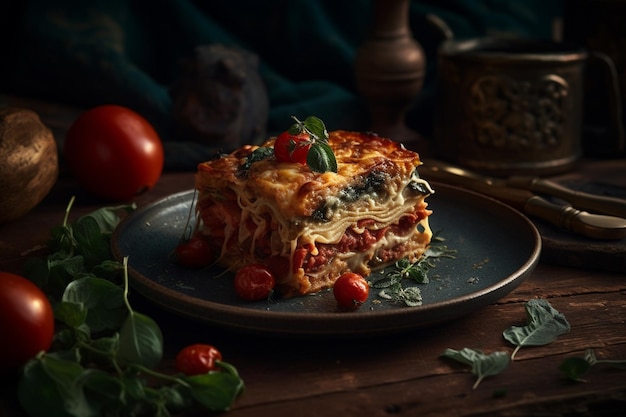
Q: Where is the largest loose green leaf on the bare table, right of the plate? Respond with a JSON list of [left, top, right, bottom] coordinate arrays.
[[502, 299, 570, 359]]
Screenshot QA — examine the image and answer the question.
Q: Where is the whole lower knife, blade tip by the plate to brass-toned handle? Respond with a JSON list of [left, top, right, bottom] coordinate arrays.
[[419, 164, 626, 240]]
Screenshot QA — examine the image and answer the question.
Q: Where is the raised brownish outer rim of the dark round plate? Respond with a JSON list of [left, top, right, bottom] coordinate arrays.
[[111, 181, 542, 336]]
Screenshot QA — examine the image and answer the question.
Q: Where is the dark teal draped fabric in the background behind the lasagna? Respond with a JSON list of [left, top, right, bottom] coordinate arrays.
[[0, 0, 562, 169]]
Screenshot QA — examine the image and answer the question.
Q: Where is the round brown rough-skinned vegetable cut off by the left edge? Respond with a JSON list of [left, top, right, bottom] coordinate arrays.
[[0, 107, 59, 224]]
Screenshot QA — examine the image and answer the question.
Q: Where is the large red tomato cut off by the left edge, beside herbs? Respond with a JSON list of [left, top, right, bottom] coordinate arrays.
[[0, 272, 54, 370]]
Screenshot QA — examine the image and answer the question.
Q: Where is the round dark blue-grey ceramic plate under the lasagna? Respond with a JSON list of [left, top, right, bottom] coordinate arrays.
[[112, 183, 541, 336]]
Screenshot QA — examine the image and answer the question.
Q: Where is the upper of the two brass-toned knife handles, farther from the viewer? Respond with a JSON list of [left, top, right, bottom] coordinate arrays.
[[507, 176, 626, 218]]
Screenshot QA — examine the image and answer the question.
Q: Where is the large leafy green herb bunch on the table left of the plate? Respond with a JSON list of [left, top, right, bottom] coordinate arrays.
[[17, 199, 244, 417]]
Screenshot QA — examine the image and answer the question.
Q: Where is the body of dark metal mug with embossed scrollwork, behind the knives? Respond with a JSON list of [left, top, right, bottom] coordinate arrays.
[[434, 38, 587, 175]]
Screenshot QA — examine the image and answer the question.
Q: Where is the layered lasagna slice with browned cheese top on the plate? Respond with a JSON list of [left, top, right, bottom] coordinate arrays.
[[195, 131, 433, 297]]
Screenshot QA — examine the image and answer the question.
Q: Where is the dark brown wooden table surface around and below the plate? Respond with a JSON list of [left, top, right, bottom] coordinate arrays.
[[0, 154, 626, 417]]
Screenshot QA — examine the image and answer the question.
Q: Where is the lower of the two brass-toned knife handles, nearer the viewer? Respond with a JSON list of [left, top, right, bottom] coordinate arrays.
[[524, 196, 626, 240]]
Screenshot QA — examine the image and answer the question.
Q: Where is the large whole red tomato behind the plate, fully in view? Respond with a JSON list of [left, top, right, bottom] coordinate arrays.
[[63, 105, 164, 201]]
